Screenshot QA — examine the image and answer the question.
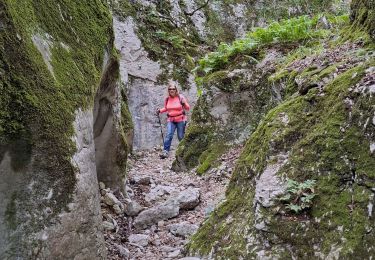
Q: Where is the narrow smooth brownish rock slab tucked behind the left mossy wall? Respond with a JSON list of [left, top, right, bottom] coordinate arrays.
[[93, 53, 127, 191]]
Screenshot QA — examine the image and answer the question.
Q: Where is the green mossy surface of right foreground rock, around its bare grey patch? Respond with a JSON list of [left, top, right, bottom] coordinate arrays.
[[187, 55, 375, 259]]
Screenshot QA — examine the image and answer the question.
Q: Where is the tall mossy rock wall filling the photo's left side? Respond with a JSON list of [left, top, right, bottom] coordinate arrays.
[[0, 0, 130, 259]]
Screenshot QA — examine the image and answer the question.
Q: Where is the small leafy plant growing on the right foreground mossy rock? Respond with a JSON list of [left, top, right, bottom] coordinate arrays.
[[279, 179, 316, 214]]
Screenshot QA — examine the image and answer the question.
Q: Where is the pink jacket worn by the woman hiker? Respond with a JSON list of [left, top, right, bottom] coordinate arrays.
[[160, 95, 190, 122]]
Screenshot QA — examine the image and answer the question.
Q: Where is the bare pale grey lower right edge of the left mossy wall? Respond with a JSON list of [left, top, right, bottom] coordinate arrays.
[[25, 110, 105, 259]]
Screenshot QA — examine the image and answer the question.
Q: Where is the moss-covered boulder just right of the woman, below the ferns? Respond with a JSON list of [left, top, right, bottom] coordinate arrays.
[[173, 48, 287, 174]]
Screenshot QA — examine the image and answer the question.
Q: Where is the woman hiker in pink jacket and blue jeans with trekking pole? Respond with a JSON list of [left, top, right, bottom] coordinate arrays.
[[156, 82, 190, 159]]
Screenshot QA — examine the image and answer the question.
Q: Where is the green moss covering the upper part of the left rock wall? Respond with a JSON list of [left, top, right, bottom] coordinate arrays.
[[0, 0, 113, 255]]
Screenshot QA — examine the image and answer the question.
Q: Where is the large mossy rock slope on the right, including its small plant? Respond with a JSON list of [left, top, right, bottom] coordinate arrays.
[[187, 1, 375, 259]]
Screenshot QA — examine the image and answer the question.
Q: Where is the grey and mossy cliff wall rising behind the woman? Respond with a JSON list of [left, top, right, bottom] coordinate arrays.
[[110, 0, 348, 149]]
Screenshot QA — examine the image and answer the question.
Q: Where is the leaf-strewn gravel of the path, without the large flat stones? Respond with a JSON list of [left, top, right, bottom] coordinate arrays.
[[101, 147, 241, 259]]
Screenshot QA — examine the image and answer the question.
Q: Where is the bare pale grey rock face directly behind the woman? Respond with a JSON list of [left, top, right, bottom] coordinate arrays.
[[113, 15, 197, 150]]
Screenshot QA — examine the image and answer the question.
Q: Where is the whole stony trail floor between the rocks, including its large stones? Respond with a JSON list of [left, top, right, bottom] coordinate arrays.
[[100, 149, 240, 259]]
